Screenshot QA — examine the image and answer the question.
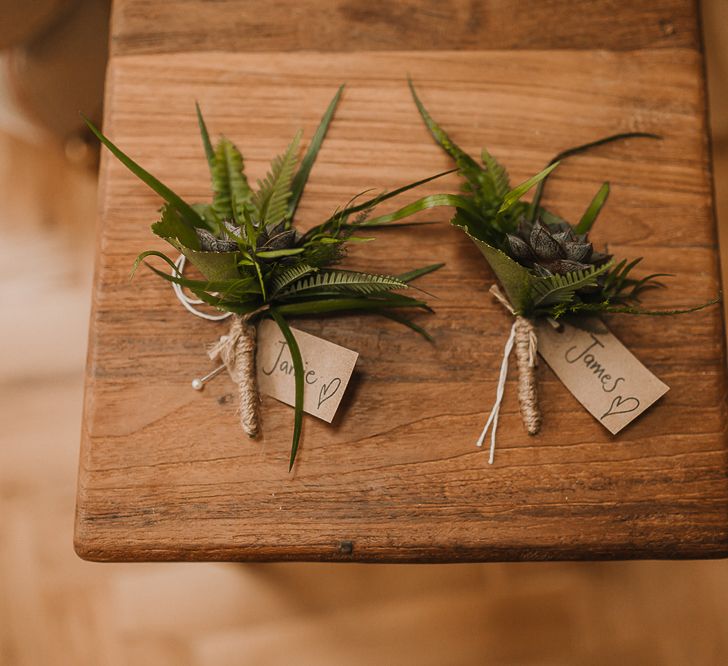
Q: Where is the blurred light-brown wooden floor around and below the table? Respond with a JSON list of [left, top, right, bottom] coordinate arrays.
[[0, 0, 728, 666]]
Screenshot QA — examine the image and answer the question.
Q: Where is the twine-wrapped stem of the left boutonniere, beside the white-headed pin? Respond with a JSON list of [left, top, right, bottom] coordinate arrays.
[[208, 315, 260, 437]]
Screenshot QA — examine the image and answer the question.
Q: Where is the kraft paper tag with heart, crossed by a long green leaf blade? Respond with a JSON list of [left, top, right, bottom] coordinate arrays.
[[256, 319, 359, 423]]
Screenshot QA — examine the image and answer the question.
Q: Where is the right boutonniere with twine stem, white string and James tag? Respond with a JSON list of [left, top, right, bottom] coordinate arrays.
[[379, 81, 719, 463]]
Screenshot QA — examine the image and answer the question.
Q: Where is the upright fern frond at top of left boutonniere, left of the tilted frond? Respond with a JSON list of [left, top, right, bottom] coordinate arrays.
[[212, 137, 253, 220]]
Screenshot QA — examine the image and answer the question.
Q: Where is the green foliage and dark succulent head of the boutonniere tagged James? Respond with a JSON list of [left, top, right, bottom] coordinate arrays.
[[374, 81, 716, 318]]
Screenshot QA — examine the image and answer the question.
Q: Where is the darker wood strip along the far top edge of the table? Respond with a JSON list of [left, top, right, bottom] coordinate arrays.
[[111, 0, 700, 56]]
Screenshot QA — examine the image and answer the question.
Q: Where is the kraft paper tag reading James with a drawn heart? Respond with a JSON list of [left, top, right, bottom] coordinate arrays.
[[538, 318, 670, 435]]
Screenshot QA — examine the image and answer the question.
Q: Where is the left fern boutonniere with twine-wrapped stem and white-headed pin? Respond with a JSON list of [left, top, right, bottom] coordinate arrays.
[[87, 86, 442, 469]]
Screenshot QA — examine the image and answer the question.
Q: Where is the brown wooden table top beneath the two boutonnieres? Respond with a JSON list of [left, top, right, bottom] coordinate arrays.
[[75, 0, 728, 562]]
